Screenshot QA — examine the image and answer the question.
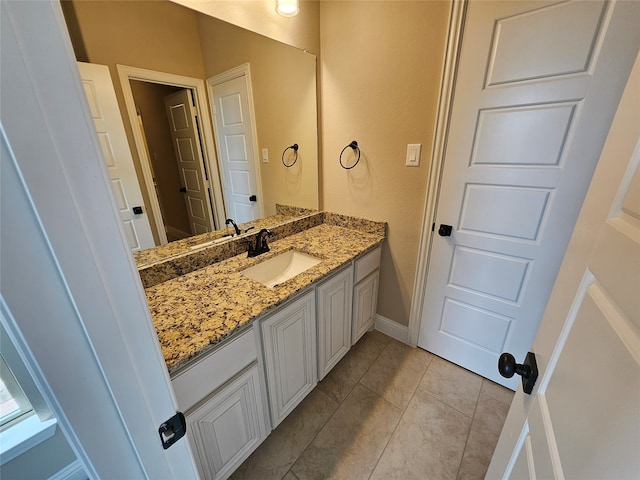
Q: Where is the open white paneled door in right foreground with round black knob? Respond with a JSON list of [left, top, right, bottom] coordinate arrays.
[[487, 52, 640, 480]]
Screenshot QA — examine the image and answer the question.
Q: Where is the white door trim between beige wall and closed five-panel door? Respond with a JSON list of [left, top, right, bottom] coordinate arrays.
[[407, 0, 467, 347]]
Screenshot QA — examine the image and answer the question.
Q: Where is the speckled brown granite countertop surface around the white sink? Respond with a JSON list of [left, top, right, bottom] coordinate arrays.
[[145, 222, 385, 373]]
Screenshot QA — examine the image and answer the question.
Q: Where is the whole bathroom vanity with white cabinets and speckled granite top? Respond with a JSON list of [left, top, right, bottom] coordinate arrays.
[[141, 212, 386, 479]]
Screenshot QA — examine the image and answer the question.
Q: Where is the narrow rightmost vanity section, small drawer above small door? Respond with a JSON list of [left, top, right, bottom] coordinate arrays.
[[351, 247, 382, 345]]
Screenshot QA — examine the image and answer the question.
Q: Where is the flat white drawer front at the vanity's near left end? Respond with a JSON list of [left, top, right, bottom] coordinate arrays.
[[171, 328, 258, 412]]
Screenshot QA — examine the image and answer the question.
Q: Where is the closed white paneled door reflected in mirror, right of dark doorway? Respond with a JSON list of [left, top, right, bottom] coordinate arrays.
[[207, 72, 262, 223]]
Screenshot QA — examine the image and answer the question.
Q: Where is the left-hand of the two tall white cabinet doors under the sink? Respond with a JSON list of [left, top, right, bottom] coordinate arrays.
[[262, 291, 318, 428]]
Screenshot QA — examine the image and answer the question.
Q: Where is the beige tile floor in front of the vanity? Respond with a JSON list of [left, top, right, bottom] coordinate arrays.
[[231, 331, 513, 480]]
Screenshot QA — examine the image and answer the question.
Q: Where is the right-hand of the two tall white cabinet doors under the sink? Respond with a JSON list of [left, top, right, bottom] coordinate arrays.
[[316, 267, 353, 380]]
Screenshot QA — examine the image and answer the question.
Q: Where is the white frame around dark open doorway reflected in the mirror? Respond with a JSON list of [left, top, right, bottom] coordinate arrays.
[[116, 64, 225, 245]]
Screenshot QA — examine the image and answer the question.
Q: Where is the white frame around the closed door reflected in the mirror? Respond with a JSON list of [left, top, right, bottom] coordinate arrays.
[[207, 63, 264, 218]]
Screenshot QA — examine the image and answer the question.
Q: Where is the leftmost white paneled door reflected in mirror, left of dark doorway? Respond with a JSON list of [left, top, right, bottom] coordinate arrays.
[[78, 62, 155, 251]]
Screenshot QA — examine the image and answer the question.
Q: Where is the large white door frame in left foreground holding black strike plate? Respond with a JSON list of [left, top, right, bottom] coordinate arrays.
[[0, 0, 197, 479]]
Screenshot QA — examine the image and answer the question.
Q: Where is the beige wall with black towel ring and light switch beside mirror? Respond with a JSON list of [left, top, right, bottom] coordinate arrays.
[[320, 1, 449, 325]]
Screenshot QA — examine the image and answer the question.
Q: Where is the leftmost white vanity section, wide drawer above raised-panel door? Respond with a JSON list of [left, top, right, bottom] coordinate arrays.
[[171, 328, 270, 480]]
